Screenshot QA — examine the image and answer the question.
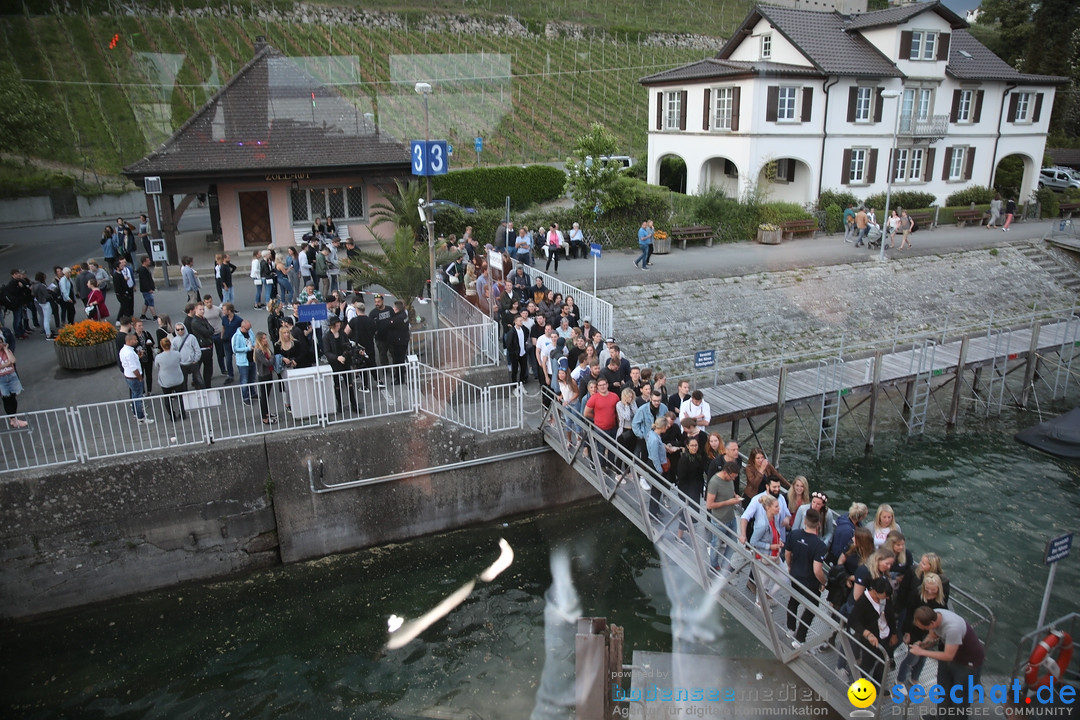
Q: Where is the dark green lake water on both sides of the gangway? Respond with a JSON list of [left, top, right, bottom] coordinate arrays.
[[0, 408, 1080, 720]]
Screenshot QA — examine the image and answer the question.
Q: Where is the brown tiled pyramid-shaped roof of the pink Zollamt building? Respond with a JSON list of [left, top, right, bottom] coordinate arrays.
[[124, 46, 409, 178]]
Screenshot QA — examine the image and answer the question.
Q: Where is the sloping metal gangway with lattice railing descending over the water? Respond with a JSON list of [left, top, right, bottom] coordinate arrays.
[[541, 398, 995, 717]]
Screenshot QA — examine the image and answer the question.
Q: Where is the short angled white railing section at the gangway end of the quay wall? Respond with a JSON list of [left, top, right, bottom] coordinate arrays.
[[417, 365, 524, 433]]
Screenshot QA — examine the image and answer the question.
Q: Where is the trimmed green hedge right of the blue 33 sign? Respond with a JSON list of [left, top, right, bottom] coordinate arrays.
[[432, 165, 566, 212]]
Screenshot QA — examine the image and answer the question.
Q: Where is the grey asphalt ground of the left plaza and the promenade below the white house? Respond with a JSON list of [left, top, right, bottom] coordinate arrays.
[[0, 208, 1052, 410]]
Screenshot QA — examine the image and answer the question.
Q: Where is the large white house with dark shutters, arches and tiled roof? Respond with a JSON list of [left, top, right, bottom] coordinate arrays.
[[640, 2, 1068, 204]]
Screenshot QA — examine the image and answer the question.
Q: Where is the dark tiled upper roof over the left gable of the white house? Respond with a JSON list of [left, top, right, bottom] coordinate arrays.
[[717, 5, 904, 78]]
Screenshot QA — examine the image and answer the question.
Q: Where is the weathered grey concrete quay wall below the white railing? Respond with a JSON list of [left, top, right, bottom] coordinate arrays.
[[0, 416, 594, 617]]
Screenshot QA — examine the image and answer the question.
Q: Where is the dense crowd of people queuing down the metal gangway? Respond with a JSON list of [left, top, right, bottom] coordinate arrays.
[[540, 367, 983, 703]]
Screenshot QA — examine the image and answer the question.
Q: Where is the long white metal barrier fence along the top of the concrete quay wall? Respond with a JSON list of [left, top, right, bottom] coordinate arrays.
[[0, 356, 523, 473]]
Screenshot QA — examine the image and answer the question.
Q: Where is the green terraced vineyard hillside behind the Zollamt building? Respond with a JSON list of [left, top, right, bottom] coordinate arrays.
[[0, 10, 725, 173]]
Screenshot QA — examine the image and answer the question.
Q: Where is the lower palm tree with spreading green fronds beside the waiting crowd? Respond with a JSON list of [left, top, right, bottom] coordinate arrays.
[[341, 225, 449, 316]]
